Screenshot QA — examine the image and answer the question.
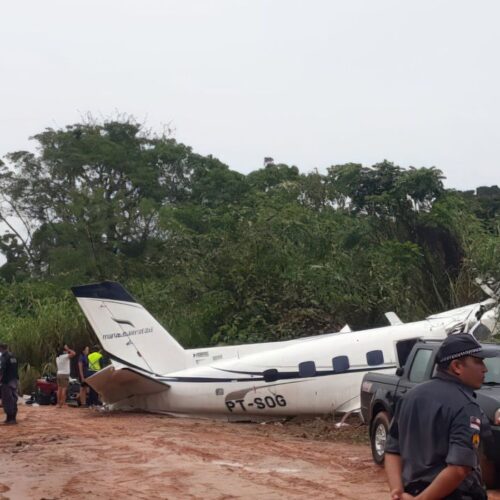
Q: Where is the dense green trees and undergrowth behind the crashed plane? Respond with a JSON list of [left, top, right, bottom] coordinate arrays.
[[0, 120, 500, 390]]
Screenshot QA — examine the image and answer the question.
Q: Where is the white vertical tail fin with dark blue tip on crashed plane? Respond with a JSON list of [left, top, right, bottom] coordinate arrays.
[[71, 281, 187, 375]]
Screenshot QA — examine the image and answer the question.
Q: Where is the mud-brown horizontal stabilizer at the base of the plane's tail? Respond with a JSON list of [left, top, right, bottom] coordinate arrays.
[[86, 365, 170, 403]]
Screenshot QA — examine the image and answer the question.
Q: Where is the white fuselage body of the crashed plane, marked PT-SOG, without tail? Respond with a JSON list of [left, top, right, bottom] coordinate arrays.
[[127, 321, 440, 418]]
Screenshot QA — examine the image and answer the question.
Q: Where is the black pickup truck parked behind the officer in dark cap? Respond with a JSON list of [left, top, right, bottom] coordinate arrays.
[[361, 341, 500, 477]]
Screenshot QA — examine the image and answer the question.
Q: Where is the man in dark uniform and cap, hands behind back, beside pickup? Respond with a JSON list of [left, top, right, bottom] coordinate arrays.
[[385, 334, 496, 500]]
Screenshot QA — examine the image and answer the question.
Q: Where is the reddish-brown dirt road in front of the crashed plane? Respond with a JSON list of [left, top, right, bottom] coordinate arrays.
[[0, 406, 500, 500]]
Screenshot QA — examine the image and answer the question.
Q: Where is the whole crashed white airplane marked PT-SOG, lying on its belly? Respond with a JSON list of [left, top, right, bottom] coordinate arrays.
[[72, 282, 498, 420]]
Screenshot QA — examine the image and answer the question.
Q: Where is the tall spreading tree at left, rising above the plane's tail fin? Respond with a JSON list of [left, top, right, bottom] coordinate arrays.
[[0, 120, 232, 279]]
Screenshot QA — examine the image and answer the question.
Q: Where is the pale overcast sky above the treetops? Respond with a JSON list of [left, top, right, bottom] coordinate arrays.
[[0, 0, 500, 189]]
